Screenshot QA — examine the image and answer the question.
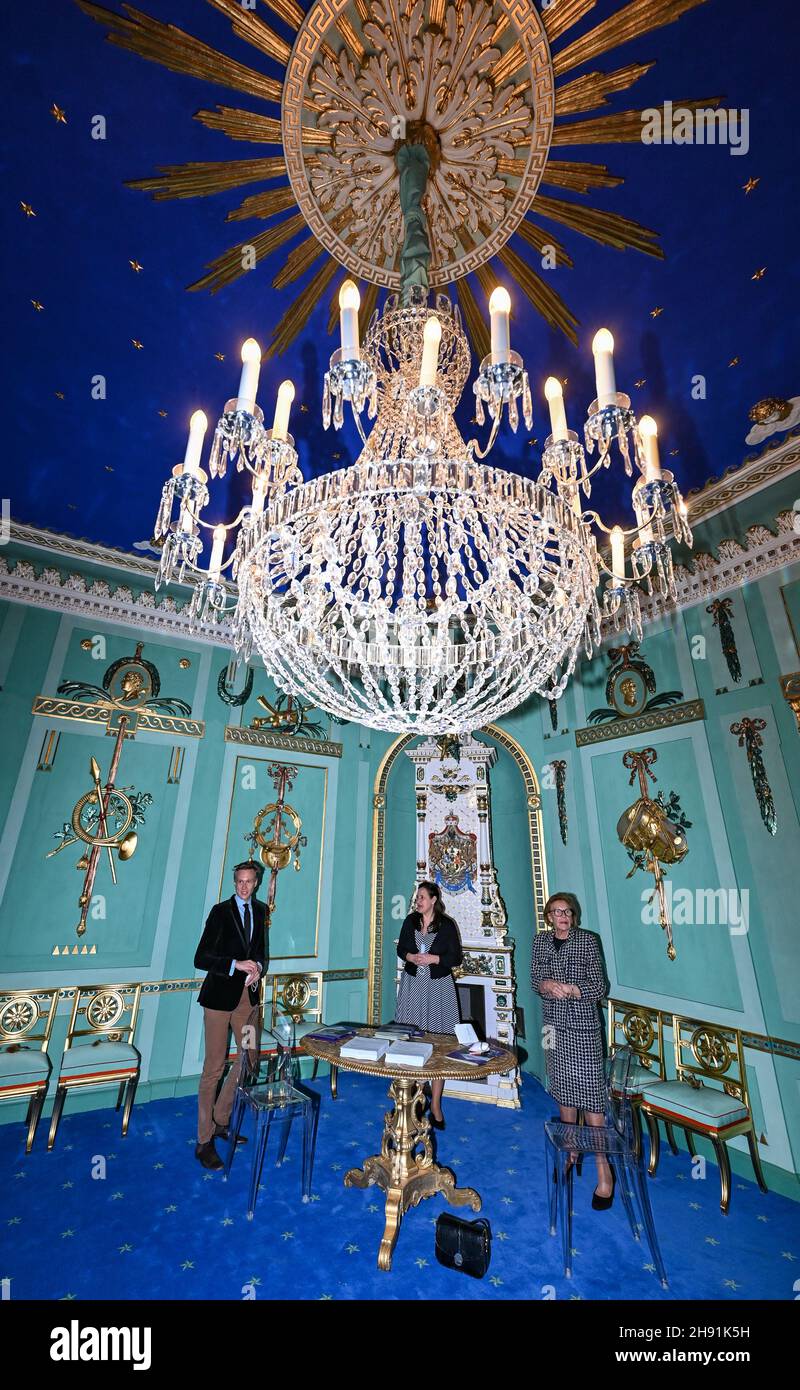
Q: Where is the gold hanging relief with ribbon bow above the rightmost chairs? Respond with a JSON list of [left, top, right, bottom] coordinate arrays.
[[617, 748, 692, 960]]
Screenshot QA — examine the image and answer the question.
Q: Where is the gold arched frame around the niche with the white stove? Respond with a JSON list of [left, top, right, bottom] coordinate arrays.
[[367, 724, 547, 1023]]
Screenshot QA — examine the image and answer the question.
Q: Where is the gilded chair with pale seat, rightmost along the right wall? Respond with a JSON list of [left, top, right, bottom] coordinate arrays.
[[642, 1015, 768, 1215]]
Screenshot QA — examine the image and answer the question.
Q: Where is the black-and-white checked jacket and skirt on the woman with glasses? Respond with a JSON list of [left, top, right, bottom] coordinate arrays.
[[531, 927, 608, 1115]]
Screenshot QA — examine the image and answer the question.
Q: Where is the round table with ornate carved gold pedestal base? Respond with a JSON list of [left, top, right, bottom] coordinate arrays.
[[300, 1029, 517, 1269]]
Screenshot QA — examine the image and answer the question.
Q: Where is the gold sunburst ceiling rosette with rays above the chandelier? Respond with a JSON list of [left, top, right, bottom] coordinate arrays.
[[76, 0, 718, 354]]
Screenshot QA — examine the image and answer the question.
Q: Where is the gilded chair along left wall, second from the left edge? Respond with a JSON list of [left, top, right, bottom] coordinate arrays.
[[47, 984, 142, 1148]]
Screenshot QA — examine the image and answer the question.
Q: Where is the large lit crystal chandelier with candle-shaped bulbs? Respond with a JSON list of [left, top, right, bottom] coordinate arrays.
[[156, 281, 692, 734]]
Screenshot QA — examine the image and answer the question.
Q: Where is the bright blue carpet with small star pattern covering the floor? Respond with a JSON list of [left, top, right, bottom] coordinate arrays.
[[0, 1074, 800, 1302]]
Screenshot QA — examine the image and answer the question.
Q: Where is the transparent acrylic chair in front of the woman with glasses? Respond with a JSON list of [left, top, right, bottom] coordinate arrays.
[[544, 1048, 667, 1289]]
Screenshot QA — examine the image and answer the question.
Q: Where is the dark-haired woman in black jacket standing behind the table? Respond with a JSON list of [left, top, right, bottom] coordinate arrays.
[[394, 880, 463, 1129]]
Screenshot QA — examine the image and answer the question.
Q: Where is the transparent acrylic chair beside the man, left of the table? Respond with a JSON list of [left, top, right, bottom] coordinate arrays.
[[225, 1006, 319, 1220]]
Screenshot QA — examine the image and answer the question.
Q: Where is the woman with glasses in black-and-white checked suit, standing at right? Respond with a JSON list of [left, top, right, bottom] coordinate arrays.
[[531, 892, 614, 1200]]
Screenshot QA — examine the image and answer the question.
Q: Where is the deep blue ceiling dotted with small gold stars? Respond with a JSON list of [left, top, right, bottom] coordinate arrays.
[[0, 0, 800, 550]]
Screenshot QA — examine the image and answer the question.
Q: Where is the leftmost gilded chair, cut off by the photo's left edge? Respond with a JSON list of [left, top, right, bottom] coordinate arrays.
[[0, 990, 60, 1154]]
